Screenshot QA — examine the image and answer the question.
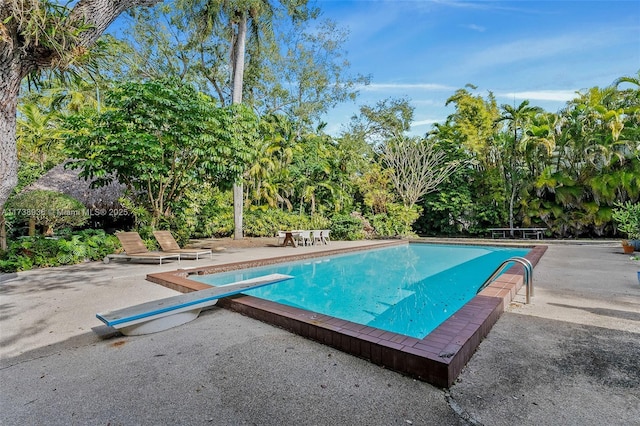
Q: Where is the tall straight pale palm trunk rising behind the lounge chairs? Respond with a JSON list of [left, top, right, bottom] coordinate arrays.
[[232, 13, 247, 240]]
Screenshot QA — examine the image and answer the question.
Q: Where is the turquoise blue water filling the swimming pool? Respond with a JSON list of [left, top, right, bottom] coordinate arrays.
[[189, 244, 529, 339]]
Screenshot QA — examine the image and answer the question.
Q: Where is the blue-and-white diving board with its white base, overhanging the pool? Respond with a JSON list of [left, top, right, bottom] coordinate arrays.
[[96, 274, 293, 336]]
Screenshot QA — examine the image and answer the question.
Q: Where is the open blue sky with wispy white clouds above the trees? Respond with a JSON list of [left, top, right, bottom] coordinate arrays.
[[317, 0, 640, 134]]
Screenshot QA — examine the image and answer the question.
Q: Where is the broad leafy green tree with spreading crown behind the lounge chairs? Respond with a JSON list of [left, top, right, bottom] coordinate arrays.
[[66, 80, 257, 226]]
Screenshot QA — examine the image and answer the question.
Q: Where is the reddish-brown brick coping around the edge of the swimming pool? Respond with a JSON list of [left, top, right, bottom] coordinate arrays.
[[147, 241, 547, 388]]
